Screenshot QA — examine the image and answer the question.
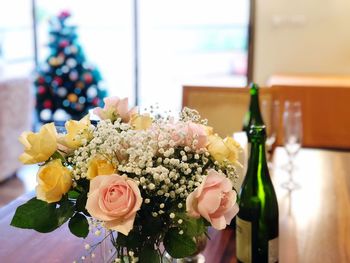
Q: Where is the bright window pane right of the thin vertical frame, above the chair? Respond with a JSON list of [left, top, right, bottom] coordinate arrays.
[[138, 0, 249, 110]]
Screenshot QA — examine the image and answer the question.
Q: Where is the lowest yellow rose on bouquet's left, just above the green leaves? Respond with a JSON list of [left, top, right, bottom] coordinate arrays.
[[36, 159, 72, 203]]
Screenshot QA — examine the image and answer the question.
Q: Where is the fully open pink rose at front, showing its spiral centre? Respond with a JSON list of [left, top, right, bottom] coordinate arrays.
[[86, 174, 142, 235]]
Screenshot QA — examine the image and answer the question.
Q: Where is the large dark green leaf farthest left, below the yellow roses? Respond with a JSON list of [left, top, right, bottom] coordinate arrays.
[[11, 197, 60, 233]]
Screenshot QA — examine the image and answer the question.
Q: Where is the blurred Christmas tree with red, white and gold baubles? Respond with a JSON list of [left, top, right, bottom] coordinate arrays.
[[35, 11, 107, 123]]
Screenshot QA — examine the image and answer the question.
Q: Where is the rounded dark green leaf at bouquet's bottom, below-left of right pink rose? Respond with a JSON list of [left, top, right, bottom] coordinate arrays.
[[163, 228, 197, 258]]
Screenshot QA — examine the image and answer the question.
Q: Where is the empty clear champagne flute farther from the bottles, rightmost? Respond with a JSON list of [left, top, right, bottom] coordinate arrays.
[[282, 100, 303, 190]]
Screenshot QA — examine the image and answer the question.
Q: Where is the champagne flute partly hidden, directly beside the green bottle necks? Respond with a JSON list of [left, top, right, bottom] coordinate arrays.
[[261, 100, 280, 163]]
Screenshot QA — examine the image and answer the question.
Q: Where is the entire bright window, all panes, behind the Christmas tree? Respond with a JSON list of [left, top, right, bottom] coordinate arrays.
[[0, 0, 249, 110]]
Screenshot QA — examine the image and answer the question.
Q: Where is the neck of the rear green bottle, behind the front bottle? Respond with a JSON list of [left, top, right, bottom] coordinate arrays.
[[242, 83, 264, 136]]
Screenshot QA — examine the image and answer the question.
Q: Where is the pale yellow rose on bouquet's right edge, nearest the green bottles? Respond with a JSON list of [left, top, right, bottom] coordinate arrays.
[[208, 134, 240, 163]]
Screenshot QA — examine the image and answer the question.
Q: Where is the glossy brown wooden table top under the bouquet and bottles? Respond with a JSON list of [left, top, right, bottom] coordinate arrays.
[[0, 148, 350, 263]]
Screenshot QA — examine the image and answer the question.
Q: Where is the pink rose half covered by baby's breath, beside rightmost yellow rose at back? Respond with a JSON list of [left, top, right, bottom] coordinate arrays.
[[172, 122, 208, 150]]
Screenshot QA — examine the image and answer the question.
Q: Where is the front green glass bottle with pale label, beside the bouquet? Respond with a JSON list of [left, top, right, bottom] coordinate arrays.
[[236, 125, 278, 263]]
